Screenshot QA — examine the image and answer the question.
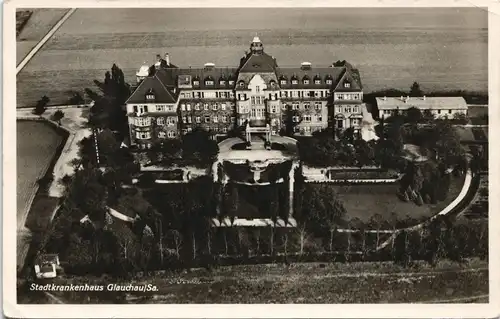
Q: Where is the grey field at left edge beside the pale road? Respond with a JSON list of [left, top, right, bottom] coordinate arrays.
[[16, 121, 64, 228]]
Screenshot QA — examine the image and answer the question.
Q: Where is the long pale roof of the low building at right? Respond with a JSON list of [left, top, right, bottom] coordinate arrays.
[[376, 96, 467, 110]]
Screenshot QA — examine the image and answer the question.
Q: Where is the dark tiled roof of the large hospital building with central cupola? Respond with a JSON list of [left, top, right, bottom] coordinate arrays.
[[126, 37, 362, 103]]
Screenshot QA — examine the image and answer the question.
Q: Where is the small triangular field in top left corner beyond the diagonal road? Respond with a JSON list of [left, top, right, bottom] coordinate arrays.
[[16, 8, 68, 65]]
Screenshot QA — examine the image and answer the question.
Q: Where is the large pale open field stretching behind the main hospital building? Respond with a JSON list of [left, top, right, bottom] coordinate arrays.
[[17, 8, 488, 107]]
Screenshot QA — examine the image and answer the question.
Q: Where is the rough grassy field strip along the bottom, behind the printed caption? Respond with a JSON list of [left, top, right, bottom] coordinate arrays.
[[20, 260, 488, 303]]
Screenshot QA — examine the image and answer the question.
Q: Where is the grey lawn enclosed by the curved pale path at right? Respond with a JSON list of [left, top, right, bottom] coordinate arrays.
[[322, 171, 465, 226]]
